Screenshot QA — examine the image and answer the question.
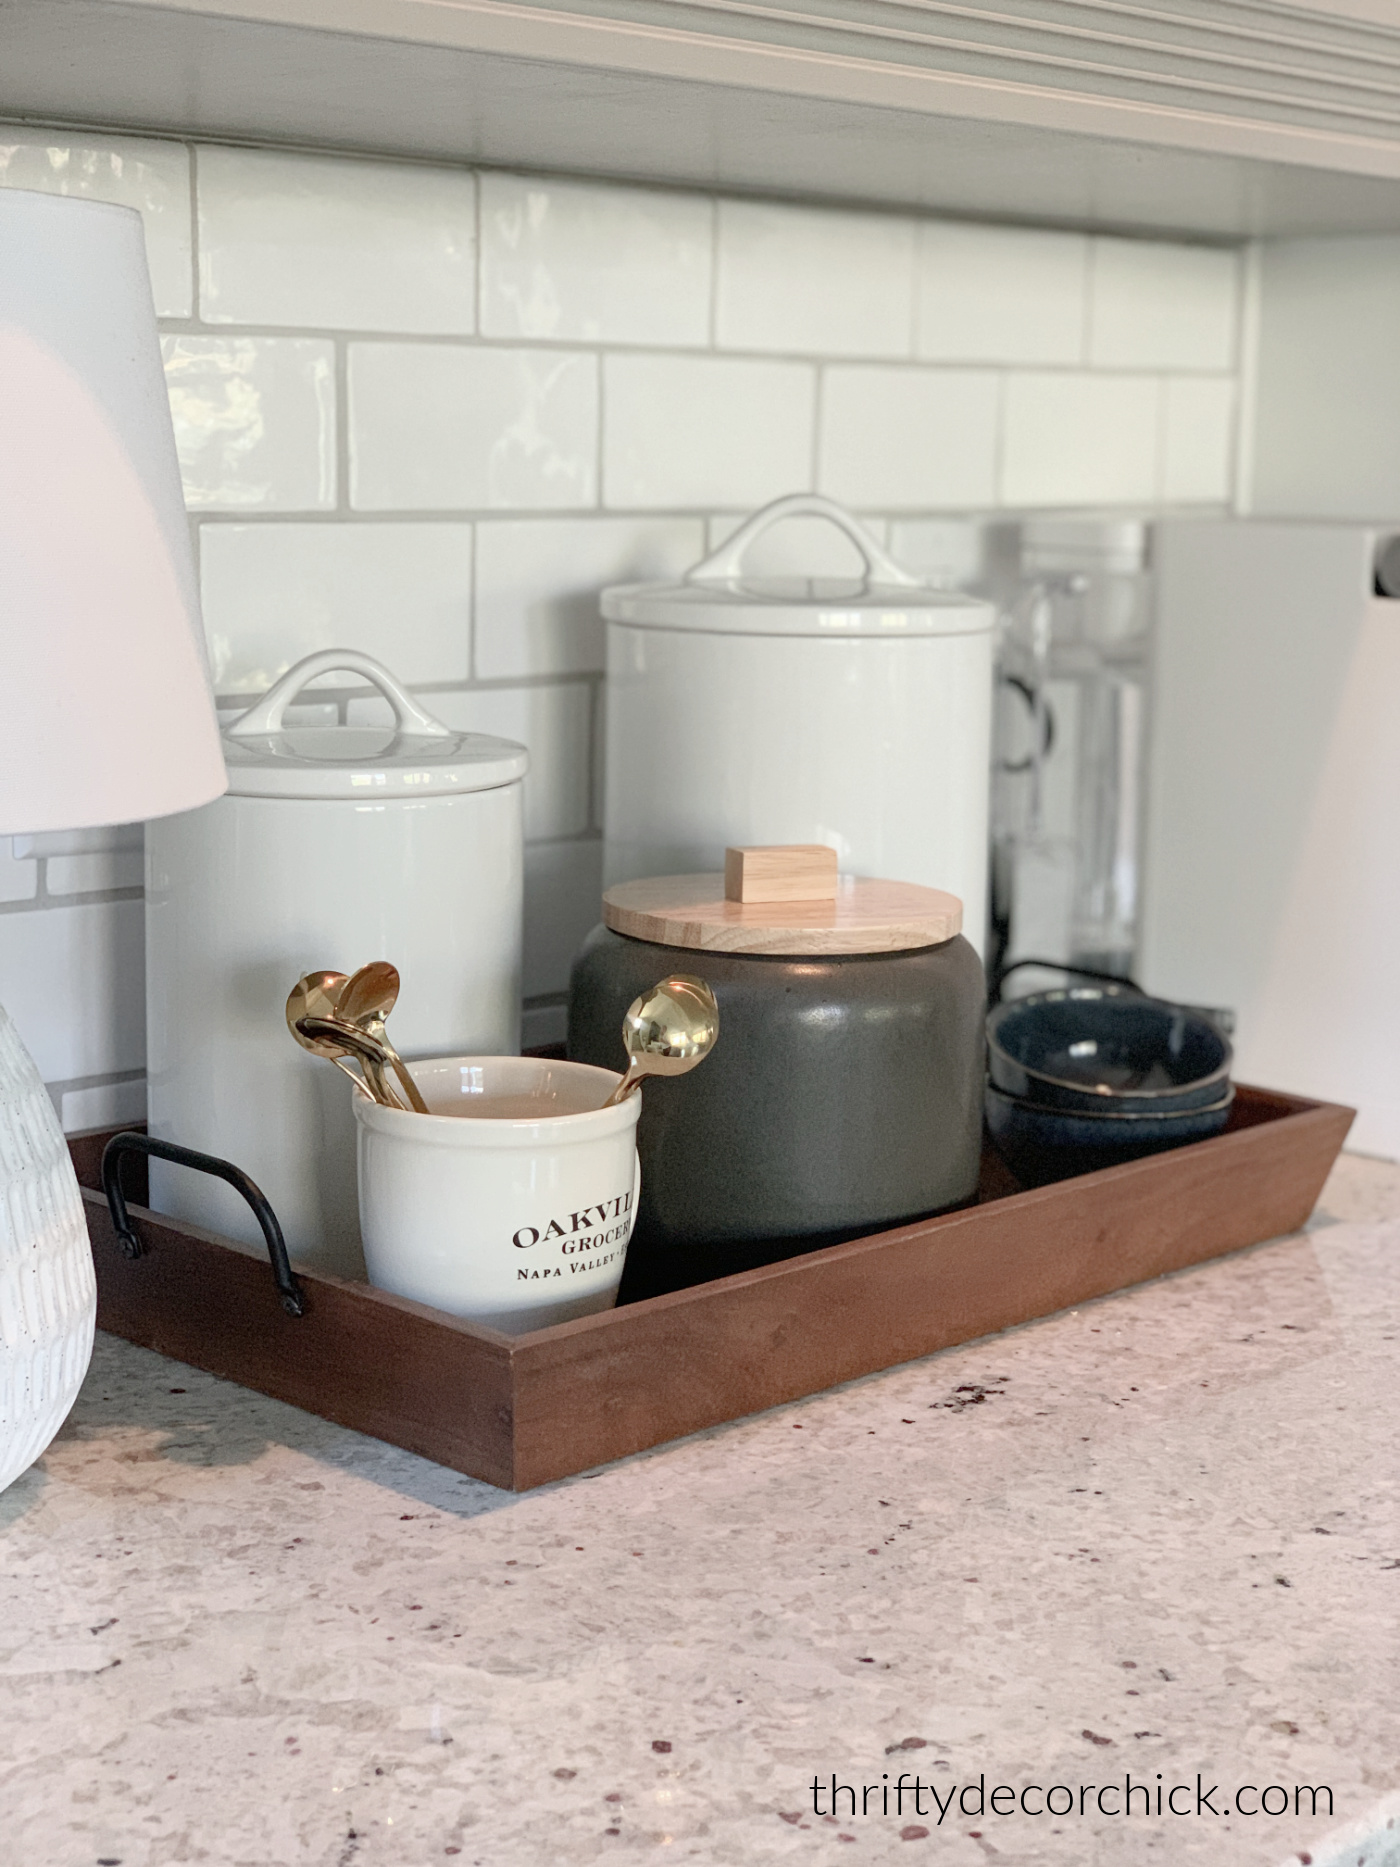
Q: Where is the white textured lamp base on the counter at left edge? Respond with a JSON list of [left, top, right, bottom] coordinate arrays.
[[0, 1004, 97, 1492]]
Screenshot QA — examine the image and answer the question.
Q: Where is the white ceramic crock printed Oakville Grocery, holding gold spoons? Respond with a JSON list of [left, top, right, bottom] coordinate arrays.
[[362, 1057, 642, 1333]]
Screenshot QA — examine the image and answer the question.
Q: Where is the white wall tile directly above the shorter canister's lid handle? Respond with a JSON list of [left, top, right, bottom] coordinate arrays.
[[200, 523, 472, 695]]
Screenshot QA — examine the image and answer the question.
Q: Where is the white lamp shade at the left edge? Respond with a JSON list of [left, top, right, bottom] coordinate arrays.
[[0, 189, 228, 835]]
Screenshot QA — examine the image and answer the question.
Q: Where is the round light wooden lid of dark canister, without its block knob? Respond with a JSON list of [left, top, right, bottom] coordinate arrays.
[[603, 874, 963, 958]]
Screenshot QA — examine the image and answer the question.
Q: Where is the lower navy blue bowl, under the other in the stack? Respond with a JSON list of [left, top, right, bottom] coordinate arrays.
[[986, 1083, 1234, 1186]]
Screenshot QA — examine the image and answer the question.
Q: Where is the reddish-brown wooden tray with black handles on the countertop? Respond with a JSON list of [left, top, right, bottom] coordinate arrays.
[[71, 1085, 1353, 1492]]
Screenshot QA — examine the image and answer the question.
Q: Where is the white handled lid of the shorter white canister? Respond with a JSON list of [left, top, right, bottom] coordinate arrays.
[[224, 648, 530, 803]]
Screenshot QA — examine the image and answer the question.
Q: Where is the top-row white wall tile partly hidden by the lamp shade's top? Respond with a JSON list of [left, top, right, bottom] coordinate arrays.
[[0, 125, 194, 317]]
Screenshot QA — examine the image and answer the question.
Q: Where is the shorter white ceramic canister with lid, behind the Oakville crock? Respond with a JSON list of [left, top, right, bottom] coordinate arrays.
[[146, 650, 528, 1277]]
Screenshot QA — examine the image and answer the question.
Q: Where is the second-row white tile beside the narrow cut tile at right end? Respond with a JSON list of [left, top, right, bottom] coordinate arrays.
[[1001, 370, 1159, 506]]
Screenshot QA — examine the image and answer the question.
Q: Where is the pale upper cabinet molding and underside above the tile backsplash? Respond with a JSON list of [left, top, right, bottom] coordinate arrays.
[[0, 0, 1400, 237]]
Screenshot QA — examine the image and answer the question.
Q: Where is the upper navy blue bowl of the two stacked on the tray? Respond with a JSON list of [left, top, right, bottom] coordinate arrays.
[[987, 986, 1232, 1115]]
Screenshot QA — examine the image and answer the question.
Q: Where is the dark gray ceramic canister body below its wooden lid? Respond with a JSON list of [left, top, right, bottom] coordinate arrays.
[[567, 877, 986, 1299]]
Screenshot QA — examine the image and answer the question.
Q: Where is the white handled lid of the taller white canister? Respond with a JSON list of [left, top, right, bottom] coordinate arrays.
[[603, 493, 995, 639]]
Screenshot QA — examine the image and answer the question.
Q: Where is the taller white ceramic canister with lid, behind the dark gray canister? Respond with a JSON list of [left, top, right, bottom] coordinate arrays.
[[603, 495, 995, 952]]
